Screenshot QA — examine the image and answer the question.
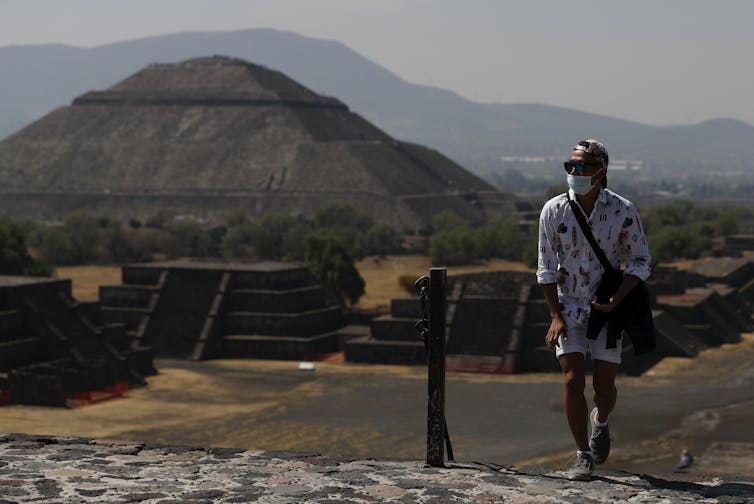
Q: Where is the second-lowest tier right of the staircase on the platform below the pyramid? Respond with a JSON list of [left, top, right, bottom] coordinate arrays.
[[221, 306, 343, 336]]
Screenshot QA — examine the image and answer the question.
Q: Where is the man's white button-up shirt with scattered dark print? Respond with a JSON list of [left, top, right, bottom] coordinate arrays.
[[537, 189, 650, 320]]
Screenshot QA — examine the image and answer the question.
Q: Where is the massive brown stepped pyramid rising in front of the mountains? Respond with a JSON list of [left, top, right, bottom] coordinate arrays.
[[0, 57, 515, 230]]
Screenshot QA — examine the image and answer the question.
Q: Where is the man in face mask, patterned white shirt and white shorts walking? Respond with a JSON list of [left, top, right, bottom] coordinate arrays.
[[537, 139, 650, 480]]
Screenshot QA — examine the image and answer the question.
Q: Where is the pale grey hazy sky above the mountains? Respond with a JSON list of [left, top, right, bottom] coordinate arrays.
[[0, 0, 754, 125]]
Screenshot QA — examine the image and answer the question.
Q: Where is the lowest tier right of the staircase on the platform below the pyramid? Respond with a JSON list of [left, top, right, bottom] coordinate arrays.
[[222, 332, 340, 360]]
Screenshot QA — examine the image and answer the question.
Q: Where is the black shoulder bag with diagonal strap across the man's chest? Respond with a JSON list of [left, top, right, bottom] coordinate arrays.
[[567, 194, 656, 355]]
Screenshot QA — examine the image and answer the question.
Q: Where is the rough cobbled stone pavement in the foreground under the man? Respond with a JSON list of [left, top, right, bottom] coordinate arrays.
[[0, 434, 754, 504]]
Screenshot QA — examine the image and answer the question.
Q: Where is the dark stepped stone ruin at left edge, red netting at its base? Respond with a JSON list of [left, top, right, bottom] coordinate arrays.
[[0, 276, 155, 406]]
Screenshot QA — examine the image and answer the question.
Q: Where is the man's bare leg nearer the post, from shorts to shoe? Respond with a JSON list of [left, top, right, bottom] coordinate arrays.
[[560, 353, 589, 451]]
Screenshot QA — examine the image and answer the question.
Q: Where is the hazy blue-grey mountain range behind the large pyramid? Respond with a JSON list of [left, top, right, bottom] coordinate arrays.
[[0, 29, 754, 173]]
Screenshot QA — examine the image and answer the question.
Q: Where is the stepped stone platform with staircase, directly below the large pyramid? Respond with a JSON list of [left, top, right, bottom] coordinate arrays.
[[100, 261, 344, 360]]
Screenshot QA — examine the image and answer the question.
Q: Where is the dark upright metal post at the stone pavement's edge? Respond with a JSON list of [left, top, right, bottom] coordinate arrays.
[[427, 268, 448, 467]]
